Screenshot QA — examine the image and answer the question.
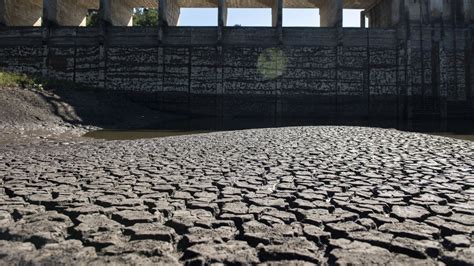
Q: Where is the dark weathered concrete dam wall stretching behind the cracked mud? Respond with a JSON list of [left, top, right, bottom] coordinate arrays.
[[0, 25, 474, 119]]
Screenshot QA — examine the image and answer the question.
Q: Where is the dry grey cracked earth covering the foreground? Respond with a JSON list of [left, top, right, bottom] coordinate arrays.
[[0, 127, 474, 265]]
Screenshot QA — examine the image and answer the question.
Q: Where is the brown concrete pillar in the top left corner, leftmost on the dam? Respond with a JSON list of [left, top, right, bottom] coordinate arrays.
[[0, 0, 43, 26]]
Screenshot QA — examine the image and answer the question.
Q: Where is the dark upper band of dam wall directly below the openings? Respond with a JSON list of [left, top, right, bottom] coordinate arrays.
[[0, 27, 397, 47]]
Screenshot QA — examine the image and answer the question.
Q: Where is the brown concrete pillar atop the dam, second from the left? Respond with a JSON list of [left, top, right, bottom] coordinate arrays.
[[43, 0, 99, 26]]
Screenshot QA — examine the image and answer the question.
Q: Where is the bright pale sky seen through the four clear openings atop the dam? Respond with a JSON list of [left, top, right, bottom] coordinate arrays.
[[178, 8, 368, 27]]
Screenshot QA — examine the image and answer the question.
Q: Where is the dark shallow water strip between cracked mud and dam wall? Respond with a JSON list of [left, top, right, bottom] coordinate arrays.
[[85, 117, 474, 141]]
